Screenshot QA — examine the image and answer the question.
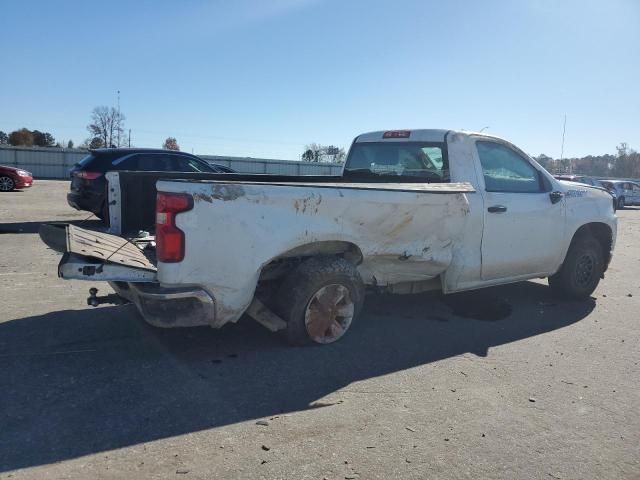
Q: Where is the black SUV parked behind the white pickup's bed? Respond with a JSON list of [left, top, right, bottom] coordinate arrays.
[[67, 148, 235, 219]]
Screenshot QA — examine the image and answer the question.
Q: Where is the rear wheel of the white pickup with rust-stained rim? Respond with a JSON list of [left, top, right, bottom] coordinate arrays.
[[277, 256, 364, 345]]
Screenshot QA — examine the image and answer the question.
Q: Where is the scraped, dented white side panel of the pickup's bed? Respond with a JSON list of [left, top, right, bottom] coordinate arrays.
[[158, 181, 473, 324]]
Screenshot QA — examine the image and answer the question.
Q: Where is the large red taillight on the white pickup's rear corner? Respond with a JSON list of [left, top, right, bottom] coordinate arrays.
[[156, 192, 193, 263]]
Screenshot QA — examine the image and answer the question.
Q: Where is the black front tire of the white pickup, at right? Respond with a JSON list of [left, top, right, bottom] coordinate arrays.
[[549, 235, 604, 299]]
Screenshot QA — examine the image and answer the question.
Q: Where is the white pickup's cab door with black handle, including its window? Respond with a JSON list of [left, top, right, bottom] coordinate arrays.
[[476, 140, 564, 280]]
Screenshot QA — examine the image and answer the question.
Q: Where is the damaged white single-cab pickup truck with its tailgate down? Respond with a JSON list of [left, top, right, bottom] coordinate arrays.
[[42, 130, 617, 344]]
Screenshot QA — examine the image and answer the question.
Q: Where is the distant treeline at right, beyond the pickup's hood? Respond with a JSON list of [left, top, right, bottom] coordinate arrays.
[[534, 143, 640, 178]]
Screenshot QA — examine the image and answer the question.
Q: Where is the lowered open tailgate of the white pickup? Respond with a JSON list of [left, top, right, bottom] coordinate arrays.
[[40, 225, 157, 282]]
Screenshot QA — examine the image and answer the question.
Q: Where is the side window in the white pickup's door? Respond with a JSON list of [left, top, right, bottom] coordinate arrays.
[[476, 141, 545, 193]]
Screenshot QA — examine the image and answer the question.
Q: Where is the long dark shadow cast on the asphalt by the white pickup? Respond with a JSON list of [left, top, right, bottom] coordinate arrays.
[[0, 282, 595, 471]]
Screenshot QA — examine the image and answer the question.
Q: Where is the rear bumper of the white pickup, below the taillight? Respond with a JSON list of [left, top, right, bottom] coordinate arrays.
[[109, 282, 215, 328]]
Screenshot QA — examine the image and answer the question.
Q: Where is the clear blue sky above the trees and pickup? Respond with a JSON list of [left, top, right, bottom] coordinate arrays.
[[0, 0, 640, 160]]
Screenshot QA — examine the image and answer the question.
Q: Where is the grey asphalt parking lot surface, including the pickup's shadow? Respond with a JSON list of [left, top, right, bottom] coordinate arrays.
[[0, 181, 640, 480]]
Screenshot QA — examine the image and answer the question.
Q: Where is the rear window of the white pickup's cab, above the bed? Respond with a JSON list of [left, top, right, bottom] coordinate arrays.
[[344, 142, 449, 182]]
